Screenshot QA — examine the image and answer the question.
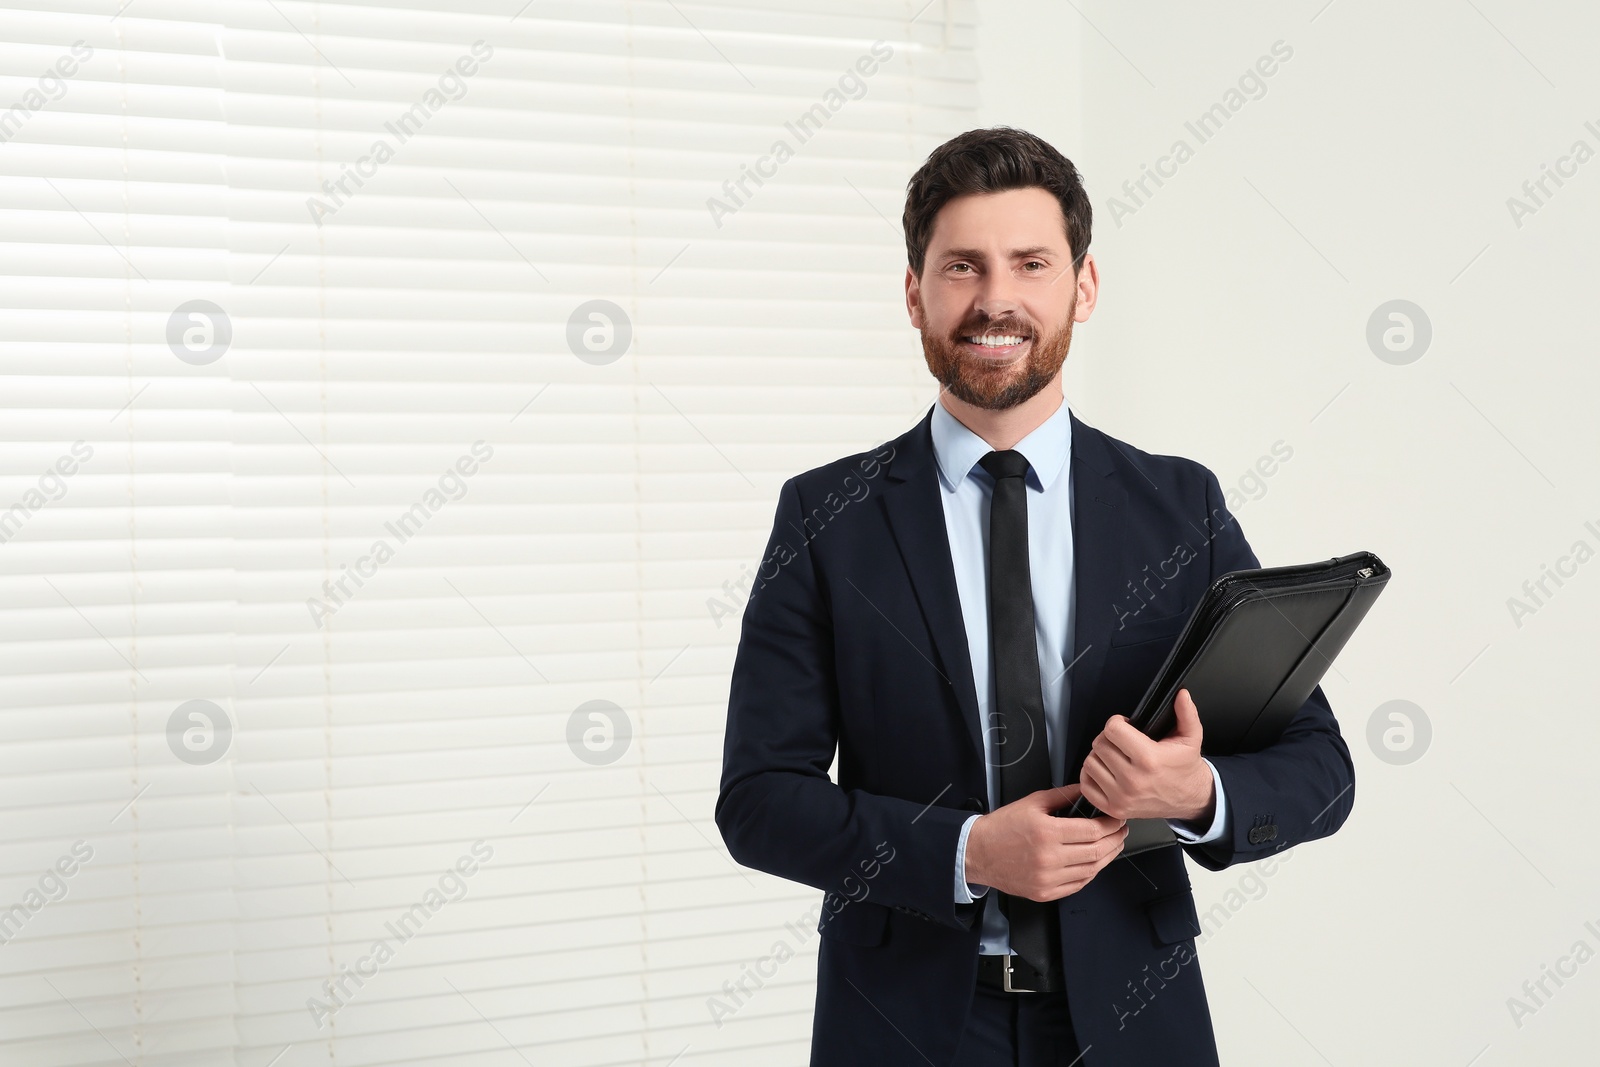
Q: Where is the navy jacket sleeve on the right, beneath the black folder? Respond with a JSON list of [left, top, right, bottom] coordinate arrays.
[[1184, 470, 1355, 870]]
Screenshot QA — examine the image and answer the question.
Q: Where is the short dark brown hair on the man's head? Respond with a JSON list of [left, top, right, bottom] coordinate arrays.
[[901, 126, 1094, 277]]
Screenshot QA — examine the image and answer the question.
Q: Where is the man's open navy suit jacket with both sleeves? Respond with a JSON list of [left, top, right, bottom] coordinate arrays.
[[717, 408, 1355, 1067]]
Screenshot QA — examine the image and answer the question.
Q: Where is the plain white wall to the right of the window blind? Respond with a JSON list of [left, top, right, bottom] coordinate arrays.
[[979, 0, 1600, 1065]]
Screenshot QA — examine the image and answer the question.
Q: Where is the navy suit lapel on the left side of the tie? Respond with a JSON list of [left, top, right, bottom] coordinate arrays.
[[883, 408, 984, 766]]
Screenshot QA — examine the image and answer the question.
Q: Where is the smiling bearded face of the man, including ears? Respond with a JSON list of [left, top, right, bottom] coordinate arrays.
[[906, 187, 1098, 411]]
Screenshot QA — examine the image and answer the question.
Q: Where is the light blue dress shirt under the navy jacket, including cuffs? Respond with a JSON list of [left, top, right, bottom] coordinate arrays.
[[933, 397, 1227, 953]]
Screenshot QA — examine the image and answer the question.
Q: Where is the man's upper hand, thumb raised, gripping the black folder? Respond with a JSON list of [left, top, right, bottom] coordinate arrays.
[[1081, 689, 1216, 830]]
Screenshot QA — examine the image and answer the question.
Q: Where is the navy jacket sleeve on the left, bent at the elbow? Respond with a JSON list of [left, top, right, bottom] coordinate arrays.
[[717, 478, 978, 929]]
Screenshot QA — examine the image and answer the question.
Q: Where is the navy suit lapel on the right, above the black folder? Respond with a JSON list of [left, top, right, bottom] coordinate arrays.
[[1066, 411, 1128, 782]]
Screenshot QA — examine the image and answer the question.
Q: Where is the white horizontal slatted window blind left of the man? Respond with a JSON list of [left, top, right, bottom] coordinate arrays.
[[0, 0, 976, 1067]]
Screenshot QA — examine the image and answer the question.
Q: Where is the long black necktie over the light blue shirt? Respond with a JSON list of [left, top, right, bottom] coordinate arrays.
[[978, 451, 1061, 973]]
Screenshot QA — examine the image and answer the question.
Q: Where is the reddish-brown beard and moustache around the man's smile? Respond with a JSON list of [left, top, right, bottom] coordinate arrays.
[[922, 298, 1078, 411]]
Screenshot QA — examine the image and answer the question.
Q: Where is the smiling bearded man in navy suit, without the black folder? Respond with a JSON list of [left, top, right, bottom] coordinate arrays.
[[717, 128, 1354, 1067]]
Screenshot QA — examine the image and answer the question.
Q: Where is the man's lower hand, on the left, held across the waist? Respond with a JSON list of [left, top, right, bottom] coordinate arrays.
[[965, 785, 1128, 902]]
